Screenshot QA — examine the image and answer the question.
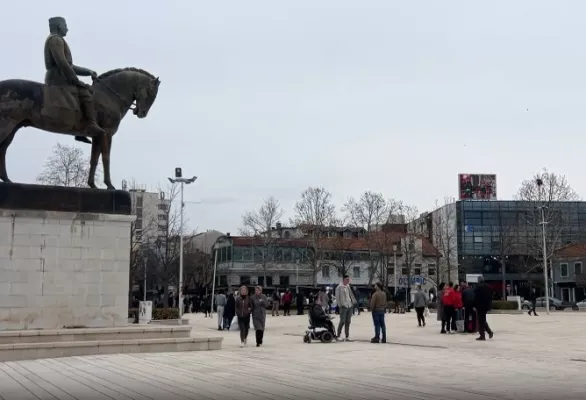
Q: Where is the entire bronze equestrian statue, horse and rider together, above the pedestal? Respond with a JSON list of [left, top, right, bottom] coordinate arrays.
[[0, 17, 161, 189]]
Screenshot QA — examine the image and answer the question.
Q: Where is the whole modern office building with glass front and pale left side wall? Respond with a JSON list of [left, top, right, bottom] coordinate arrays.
[[411, 200, 586, 295]]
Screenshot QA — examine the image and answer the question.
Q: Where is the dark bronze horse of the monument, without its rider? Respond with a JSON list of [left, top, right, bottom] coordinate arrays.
[[0, 68, 160, 189]]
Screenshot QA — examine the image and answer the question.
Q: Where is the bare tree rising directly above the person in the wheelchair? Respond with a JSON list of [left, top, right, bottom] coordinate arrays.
[[291, 187, 336, 286]]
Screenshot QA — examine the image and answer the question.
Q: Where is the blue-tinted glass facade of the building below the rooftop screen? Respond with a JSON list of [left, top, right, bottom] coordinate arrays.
[[456, 201, 586, 281]]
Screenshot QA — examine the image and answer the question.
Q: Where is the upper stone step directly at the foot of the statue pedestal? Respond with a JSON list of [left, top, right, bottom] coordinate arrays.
[[0, 325, 192, 345]]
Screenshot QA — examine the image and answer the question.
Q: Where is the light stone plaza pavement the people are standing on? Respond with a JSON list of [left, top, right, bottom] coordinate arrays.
[[0, 312, 586, 400]]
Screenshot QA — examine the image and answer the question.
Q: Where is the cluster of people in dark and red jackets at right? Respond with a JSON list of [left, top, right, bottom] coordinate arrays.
[[437, 277, 494, 340]]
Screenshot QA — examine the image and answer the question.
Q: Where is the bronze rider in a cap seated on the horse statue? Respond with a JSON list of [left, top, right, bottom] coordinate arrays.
[[45, 17, 104, 144]]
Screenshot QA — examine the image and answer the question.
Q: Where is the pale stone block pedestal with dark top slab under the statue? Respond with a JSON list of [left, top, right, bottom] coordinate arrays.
[[0, 184, 135, 330]]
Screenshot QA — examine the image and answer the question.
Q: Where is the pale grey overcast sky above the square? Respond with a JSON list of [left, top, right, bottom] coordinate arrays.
[[0, 0, 586, 232]]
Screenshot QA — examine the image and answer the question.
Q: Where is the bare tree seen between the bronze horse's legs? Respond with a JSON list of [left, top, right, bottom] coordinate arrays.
[[37, 143, 99, 187]]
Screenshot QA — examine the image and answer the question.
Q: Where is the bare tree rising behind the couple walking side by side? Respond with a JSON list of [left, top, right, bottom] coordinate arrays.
[[240, 196, 284, 286]]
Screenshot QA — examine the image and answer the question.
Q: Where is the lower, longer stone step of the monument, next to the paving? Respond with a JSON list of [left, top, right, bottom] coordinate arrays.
[[0, 337, 223, 362]]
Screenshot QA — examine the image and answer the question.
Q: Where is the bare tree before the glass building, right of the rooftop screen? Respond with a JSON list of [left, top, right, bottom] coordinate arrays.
[[516, 168, 579, 292]]
